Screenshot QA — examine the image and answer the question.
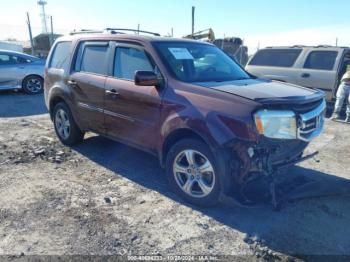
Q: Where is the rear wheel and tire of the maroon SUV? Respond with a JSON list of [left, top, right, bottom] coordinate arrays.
[[53, 102, 84, 146]]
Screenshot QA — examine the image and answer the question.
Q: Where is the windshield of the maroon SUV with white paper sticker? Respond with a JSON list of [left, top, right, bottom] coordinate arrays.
[[155, 42, 250, 82]]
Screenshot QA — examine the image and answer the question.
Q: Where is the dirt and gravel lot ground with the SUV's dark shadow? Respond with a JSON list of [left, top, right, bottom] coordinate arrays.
[[0, 93, 350, 260]]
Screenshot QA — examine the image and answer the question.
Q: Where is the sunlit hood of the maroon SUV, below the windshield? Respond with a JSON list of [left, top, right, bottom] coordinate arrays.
[[195, 79, 324, 104]]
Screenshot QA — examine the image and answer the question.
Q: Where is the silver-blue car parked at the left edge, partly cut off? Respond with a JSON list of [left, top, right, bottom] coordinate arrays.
[[0, 49, 45, 95]]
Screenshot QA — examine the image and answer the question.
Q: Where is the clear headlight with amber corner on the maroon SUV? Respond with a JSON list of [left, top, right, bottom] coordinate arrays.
[[254, 110, 297, 139]]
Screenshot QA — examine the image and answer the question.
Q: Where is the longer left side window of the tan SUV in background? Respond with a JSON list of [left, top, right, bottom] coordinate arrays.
[[249, 49, 301, 67]]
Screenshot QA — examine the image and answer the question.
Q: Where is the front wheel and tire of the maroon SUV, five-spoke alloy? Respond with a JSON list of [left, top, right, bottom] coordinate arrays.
[[166, 139, 222, 206]]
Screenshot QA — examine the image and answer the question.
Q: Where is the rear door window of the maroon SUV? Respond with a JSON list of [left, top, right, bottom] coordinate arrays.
[[75, 42, 108, 75]]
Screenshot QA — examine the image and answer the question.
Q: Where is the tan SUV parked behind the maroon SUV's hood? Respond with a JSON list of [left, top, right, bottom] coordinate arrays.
[[246, 46, 350, 101]]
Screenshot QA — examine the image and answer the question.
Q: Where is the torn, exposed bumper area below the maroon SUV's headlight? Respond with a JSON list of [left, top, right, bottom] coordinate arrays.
[[231, 139, 318, 209]]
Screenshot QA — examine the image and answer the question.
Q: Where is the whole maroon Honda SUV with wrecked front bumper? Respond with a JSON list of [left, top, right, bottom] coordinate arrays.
[[44, 32, 326, 206]]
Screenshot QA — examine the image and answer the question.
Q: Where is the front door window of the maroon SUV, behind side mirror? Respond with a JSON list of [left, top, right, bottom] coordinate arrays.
[[113, 47, 154, 80]]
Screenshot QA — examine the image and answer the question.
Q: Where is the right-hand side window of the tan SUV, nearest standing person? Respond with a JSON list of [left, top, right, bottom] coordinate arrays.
[[304, 51, 338, 70]]
